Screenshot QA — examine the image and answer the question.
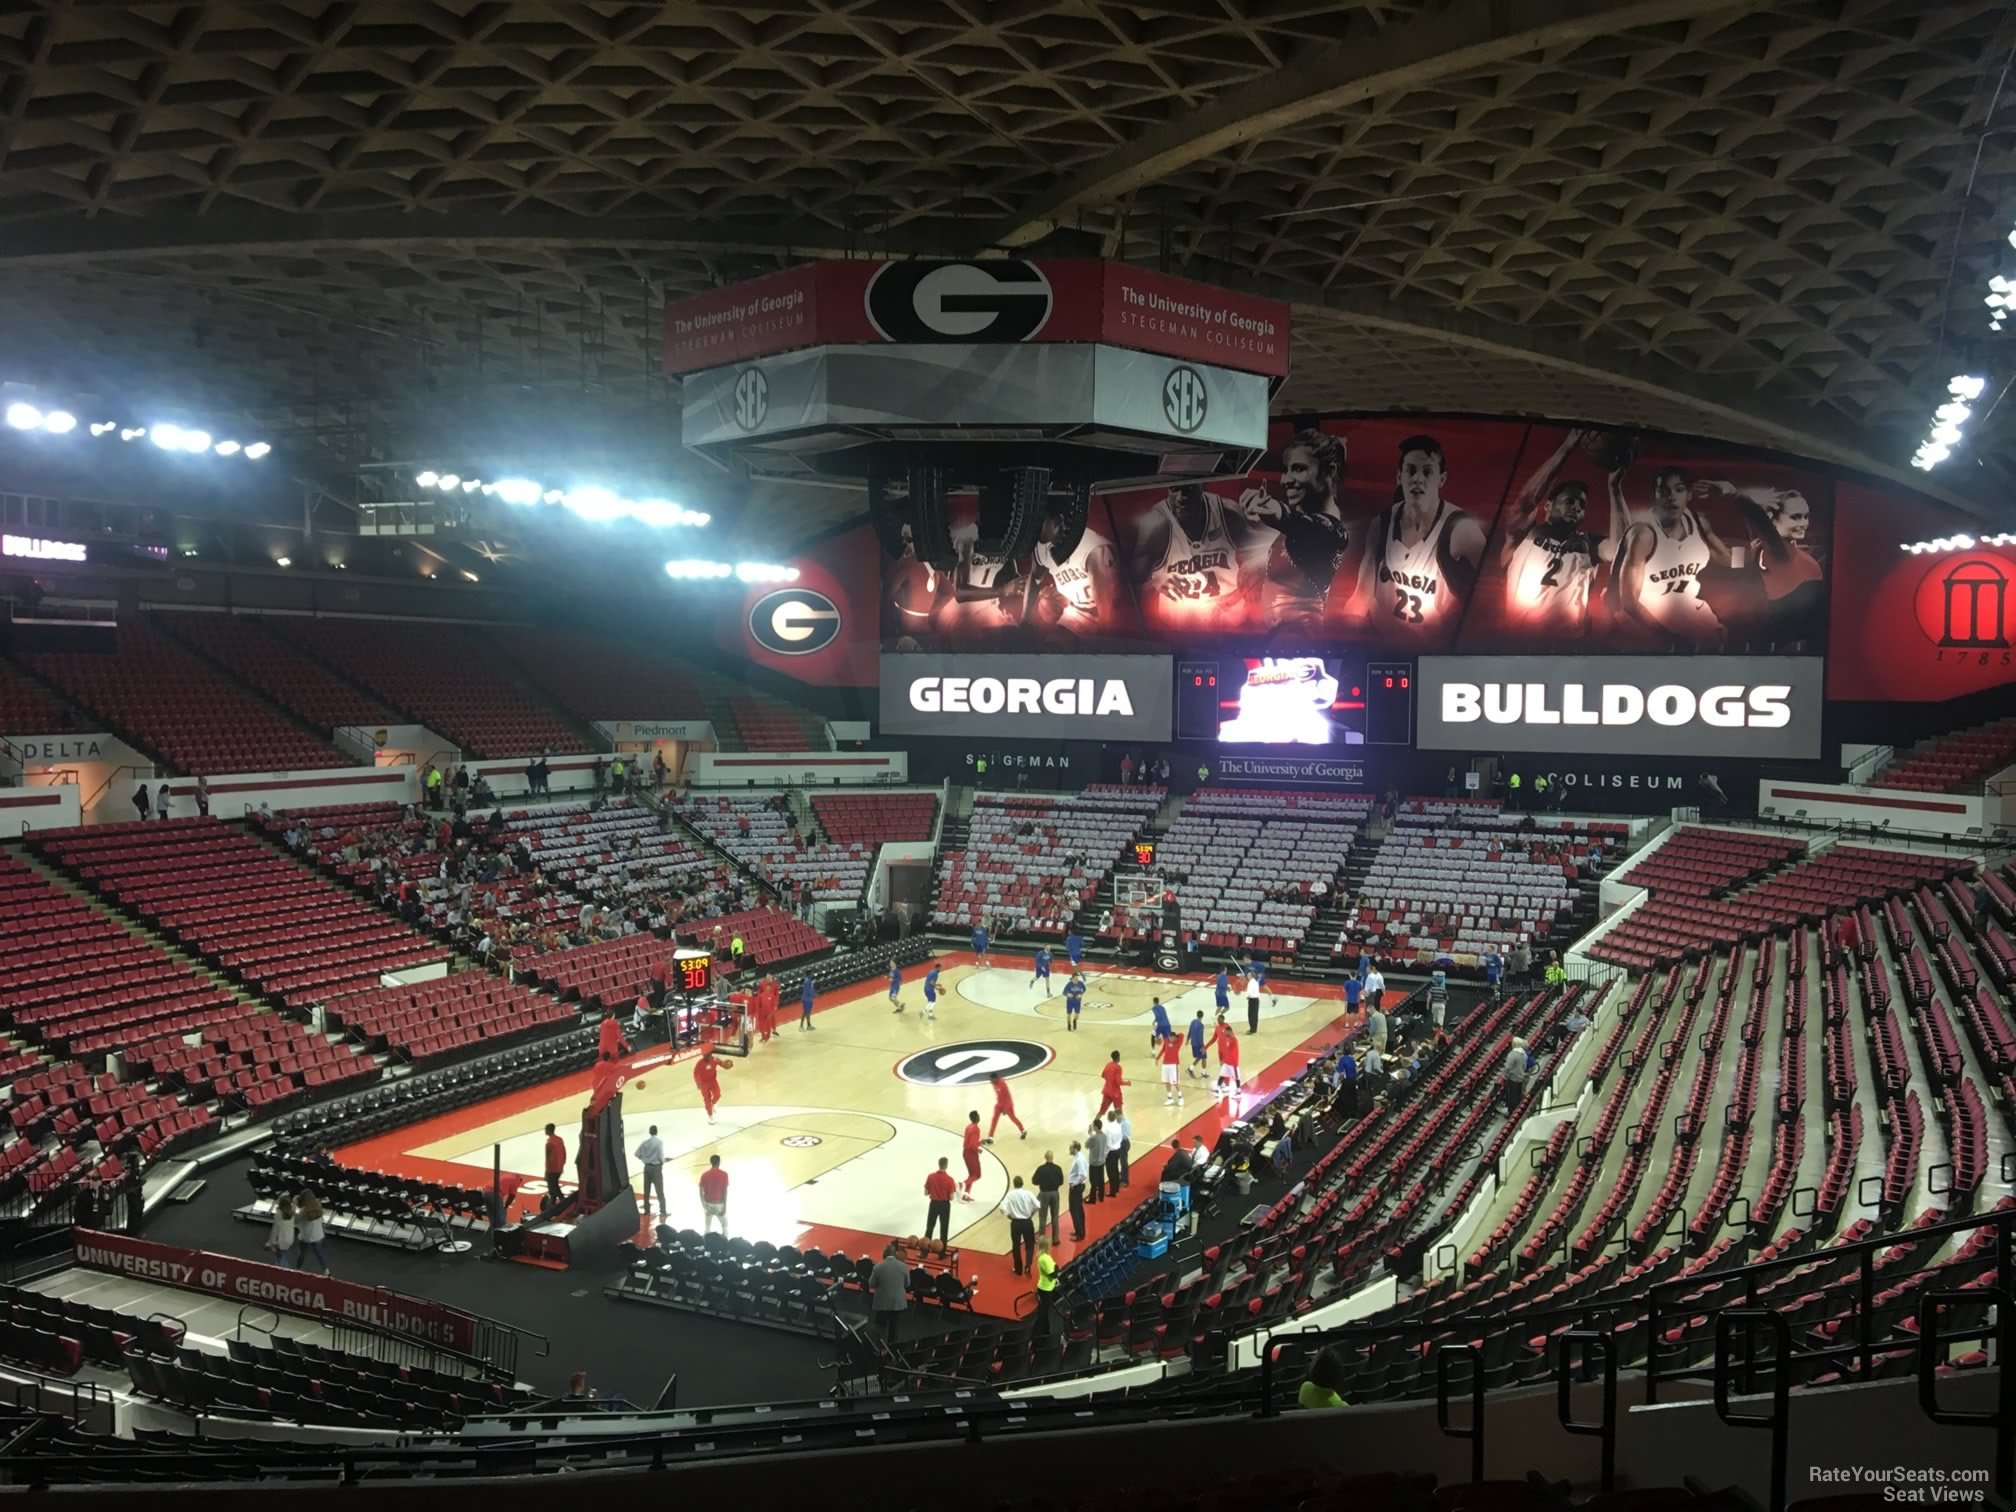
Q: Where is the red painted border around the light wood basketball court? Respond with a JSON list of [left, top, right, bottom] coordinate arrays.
[[335, 950, 1365, 1318]]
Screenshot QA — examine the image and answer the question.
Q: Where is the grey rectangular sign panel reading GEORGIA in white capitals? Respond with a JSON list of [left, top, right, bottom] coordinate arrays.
[[881, 653, 1173, 740]]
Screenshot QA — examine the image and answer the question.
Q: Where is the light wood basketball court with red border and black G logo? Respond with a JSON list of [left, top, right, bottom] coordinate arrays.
[[337, 952, 1345, 1314]]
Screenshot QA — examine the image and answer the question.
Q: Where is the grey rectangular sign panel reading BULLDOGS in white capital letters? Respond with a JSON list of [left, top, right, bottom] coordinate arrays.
[[1415, 657, 1826, 760]]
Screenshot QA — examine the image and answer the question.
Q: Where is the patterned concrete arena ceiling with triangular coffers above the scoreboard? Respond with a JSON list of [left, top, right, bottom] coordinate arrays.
[[0, 0, 2016, 552]]
